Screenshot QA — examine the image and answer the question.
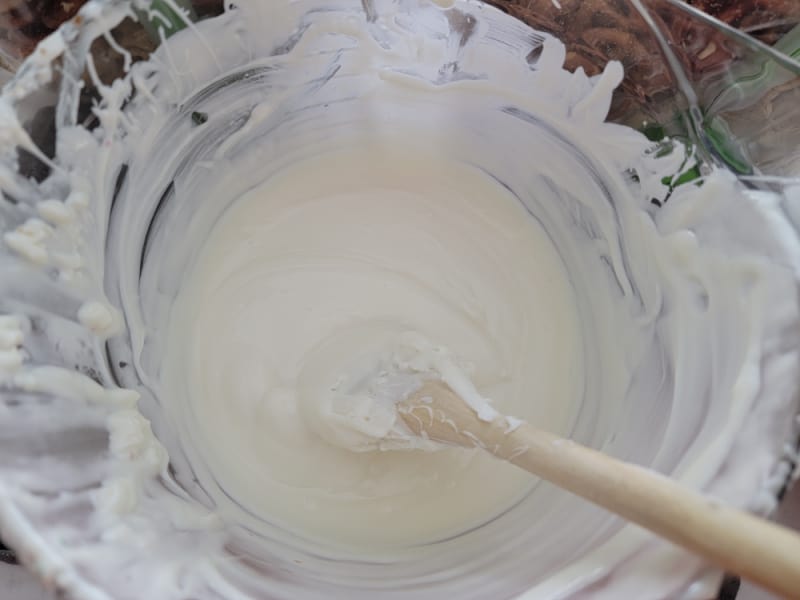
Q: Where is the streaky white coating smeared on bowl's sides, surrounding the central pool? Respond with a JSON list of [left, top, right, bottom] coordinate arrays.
[[0, 0, 800, 600]]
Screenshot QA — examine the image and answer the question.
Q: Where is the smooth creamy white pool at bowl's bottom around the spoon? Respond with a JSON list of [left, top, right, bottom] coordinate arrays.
[[162, 144, 583, 551]]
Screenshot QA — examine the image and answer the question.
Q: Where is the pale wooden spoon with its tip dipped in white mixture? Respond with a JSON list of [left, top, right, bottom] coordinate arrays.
[[398, 381, 800, 598]]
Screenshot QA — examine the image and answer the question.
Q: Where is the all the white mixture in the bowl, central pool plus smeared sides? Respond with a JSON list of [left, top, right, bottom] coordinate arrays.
[[0, 0, 800, 600]]
